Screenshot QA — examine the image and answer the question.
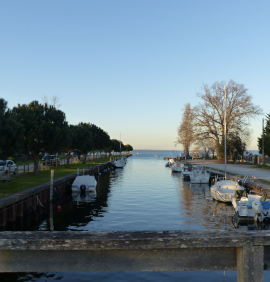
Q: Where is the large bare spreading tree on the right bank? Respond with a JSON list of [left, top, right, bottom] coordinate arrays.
[[192, 80, 262, 160]]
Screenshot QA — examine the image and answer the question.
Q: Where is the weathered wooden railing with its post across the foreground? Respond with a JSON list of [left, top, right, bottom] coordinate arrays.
[[0, 230, 270, 282]]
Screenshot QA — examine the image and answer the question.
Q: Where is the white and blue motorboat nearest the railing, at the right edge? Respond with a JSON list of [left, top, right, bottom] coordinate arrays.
[[232, 194, 270, 222]]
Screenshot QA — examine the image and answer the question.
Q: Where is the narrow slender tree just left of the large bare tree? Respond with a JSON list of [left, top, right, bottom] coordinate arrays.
[[176, 103, 193, 155]]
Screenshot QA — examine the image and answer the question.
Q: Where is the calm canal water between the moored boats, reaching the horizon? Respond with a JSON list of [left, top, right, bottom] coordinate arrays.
[[4, 151, 268, 281]]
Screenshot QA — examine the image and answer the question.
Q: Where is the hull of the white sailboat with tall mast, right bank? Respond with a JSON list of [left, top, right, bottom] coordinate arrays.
[[210, 179, 245, 202]]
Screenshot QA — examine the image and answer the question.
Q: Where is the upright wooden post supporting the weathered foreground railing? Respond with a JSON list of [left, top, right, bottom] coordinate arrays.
[[236, 244, 264, 282]]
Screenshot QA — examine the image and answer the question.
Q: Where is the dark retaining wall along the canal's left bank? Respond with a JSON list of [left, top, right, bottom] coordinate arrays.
[[0, 162, 114, 230]]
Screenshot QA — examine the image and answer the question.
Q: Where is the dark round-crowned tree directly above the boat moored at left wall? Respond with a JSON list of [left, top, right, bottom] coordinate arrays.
[[72, 122, 94, 163]]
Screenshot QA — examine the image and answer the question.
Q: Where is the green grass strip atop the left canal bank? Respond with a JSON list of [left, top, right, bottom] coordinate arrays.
[[0, 157, 110, 198]]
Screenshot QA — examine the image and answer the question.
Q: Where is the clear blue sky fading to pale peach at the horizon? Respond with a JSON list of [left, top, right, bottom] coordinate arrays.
[[0, 0, 270, 150]]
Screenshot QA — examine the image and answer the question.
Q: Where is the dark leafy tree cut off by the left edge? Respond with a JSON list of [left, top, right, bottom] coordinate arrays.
[[0, 98, 22, 158]]
